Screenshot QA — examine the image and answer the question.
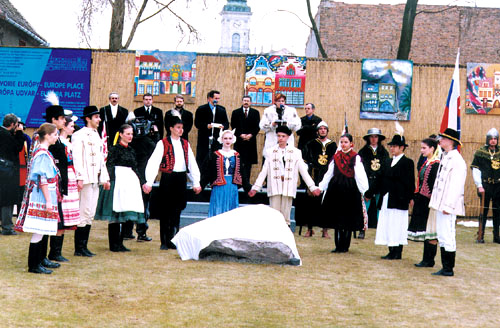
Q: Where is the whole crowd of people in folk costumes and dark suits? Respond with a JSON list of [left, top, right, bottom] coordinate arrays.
[[0, 90, 492, 276]]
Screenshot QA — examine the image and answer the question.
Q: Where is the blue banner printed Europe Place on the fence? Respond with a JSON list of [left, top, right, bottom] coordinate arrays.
[[0, 47, 92, 127]]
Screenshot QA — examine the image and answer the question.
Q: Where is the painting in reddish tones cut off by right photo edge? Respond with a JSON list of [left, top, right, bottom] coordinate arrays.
[[465, 63, 500, 115]]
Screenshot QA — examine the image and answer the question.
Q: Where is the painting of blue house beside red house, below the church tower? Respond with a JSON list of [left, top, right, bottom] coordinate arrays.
[[245, 55, 306, 107]]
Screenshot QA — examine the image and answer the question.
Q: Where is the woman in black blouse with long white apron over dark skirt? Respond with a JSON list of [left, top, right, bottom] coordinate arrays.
[[95, 124, 146, 252]]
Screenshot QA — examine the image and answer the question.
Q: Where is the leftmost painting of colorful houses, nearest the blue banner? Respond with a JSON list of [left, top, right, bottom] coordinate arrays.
[[134, 50, 196, 97]]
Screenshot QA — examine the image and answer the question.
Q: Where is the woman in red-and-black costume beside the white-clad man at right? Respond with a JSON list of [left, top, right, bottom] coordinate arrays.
[[408, 138, 440, 267]]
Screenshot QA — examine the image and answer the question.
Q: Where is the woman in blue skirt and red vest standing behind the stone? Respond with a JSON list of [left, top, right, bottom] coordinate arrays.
[[201, 130, 242, 217]]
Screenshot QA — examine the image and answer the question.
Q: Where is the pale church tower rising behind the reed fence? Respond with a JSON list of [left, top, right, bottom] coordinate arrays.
[[219, 0, 252, 53]]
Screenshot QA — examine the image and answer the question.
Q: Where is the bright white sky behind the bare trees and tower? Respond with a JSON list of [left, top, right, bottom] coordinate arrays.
[[10, 0, 500, 55]]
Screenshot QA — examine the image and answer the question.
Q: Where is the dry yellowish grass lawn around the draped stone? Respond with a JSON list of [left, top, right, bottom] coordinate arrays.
[[0, 221, 500, 327]]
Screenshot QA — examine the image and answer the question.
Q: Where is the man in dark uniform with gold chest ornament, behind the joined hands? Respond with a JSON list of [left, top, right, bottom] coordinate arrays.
[[295, 121, 337, 238]]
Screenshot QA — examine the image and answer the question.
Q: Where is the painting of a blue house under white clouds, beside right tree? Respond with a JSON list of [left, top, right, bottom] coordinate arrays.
[[360, 59, 413, 121]]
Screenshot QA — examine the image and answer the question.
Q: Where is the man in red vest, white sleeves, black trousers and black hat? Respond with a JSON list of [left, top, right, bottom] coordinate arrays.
[[142, 115, 201, 250]]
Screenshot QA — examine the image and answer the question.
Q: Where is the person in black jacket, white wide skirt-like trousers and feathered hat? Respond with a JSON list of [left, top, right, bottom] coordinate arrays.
[[365, 122, 415, 260]]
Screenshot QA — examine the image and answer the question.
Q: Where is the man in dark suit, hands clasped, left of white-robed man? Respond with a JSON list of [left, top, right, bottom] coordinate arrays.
[[231, 96, 260, 192]]
